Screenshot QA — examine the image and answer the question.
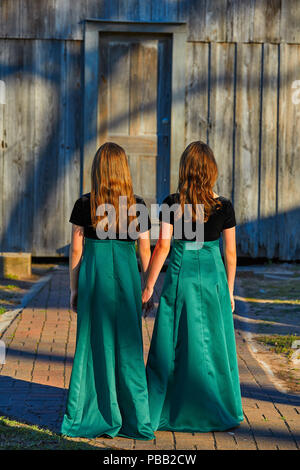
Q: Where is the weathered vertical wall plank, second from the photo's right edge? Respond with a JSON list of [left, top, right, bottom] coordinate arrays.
[[259, 44, 278, 257]]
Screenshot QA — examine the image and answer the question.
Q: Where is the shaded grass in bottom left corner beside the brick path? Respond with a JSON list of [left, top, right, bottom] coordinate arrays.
[[0, 416, 104, 451]]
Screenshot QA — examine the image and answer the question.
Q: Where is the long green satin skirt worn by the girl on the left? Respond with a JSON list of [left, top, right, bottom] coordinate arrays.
[[61, 238, 155, 440]]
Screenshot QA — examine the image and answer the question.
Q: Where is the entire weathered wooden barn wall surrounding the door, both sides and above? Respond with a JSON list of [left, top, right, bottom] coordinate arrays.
[[0, 0, 300, 260]]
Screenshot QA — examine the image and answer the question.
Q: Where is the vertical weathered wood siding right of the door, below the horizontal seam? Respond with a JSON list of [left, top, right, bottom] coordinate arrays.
[[185, 42, 300, 260]]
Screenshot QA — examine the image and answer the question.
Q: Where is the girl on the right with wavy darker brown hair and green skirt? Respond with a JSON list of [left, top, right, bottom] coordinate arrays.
[[143, 141, 243, 432]]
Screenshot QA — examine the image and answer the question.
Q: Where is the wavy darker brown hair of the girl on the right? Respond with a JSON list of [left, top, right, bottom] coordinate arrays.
[[178, 140, 222, 222]]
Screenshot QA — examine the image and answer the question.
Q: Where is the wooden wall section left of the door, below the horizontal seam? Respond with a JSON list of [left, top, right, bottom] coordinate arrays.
[[0, 39, 82, 255]]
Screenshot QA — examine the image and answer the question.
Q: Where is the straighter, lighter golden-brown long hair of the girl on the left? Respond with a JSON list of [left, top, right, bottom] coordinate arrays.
[[91, 142, 136, 231]]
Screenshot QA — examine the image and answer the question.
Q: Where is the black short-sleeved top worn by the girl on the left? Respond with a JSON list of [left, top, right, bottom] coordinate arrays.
[[70, 193, 151, 242]]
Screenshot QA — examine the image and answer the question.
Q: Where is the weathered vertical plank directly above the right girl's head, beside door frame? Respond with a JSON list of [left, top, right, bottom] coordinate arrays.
[[185, 43, 209, 145]]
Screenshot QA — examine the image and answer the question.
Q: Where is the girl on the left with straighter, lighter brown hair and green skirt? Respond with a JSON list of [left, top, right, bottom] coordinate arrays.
[[61, 143, 154, 440]]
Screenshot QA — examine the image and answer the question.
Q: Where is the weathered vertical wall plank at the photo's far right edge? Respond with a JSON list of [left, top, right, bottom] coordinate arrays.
[[277, 45, 300, 260]]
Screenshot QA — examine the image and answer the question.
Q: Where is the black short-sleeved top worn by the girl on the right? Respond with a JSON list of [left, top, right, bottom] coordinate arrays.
[[159, 193, 236, 241]]
